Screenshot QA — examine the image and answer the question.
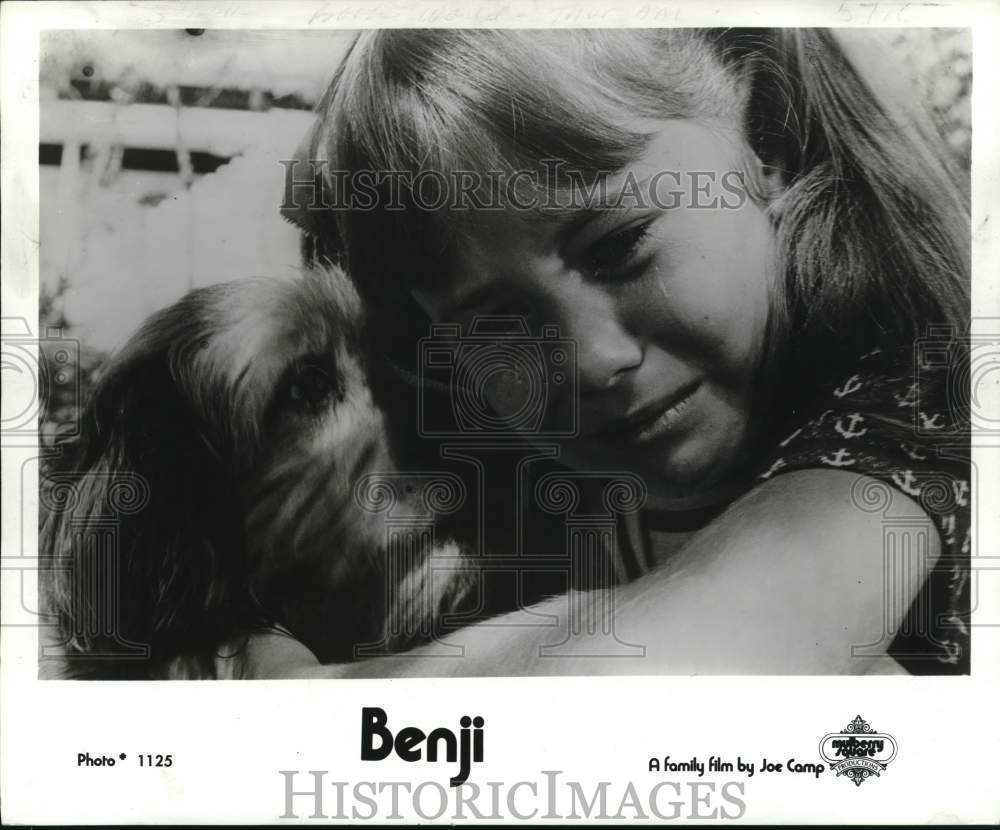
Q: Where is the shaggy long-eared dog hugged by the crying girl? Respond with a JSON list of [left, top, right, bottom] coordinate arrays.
[[41, 270, 470, 678]]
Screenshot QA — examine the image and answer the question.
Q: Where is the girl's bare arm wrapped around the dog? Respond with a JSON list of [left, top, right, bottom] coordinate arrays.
[[251, 470, 940, 678]]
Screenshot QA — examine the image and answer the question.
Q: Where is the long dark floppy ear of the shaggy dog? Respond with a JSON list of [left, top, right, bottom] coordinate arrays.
[[40, 307, 262, 678]]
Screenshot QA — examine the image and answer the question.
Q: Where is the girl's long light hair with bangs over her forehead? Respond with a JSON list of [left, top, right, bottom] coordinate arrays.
[[297, 29, 969, 412]]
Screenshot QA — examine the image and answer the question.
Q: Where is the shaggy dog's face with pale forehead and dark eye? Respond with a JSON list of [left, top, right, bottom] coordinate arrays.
[[174, 271, 394, 584]]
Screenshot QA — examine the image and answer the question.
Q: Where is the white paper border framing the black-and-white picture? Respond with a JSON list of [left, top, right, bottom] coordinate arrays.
[[0, 0, 1000, 824]]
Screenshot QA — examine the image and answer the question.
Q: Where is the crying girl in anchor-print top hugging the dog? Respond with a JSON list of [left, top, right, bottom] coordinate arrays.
[[264, 29, 970, 677]]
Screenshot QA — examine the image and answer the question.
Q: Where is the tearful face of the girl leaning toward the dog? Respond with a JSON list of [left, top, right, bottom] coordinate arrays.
[[416, 120, 775, 495]]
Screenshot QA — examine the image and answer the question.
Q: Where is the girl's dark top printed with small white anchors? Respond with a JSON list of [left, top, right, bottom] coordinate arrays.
[[618, 350, 973, 674]]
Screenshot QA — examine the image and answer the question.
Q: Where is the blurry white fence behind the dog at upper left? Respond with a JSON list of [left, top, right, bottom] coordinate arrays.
[[40, 100, 312, 349]]
